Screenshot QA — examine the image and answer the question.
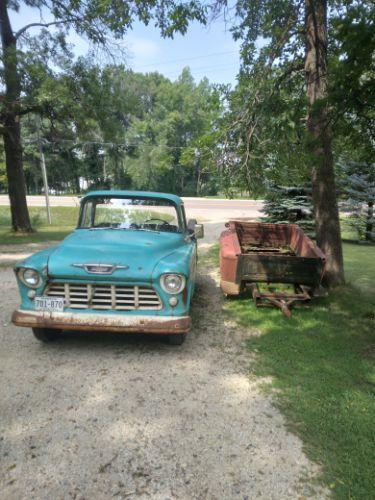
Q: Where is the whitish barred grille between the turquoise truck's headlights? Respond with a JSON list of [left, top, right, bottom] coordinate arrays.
[[45, 282, 162, 311]]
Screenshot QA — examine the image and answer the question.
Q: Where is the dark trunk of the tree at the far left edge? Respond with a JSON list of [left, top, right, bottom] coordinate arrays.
[[0, 0, 32, 232]]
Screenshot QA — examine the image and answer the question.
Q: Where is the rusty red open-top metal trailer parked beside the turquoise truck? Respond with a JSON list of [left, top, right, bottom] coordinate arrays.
[[220, 220, 326, 317]]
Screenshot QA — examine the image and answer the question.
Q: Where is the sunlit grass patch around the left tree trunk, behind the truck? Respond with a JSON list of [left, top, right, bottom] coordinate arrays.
[[0, 207, 78, 244]]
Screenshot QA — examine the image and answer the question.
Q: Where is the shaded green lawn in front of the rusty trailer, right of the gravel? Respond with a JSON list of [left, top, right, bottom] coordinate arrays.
[[214, 243, 375, 499]]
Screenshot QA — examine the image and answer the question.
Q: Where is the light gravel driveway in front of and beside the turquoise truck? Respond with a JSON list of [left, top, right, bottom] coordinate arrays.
[[0, 262, 325, 500]]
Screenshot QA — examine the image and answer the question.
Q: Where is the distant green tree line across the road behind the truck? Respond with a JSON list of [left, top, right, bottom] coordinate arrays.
[[0, 65, 224, 196]]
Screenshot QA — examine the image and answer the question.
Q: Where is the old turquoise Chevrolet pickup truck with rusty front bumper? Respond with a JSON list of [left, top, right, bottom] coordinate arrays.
[[12, 191, 203, 344]]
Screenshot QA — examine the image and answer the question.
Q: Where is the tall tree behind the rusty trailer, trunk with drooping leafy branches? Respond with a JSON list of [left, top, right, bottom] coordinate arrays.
[[216, 0, 371, 286]]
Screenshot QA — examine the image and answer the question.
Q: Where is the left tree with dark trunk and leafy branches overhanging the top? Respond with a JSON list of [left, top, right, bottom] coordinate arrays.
[[0, 0, 205, 232]]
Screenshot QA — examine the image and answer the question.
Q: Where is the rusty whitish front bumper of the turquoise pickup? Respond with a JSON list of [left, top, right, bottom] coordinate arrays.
[[12, 309, 191, 334]]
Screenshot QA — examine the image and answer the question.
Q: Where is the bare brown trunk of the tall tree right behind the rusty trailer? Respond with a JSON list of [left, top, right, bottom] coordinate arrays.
[[305, 0, 344, 286]]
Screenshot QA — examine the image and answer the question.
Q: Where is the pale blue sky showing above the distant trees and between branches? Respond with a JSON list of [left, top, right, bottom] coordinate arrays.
[[11, 6, 239, 86]]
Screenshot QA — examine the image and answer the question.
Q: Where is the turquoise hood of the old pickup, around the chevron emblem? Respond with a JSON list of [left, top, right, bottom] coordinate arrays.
[[48, 229, 184, 281]]
